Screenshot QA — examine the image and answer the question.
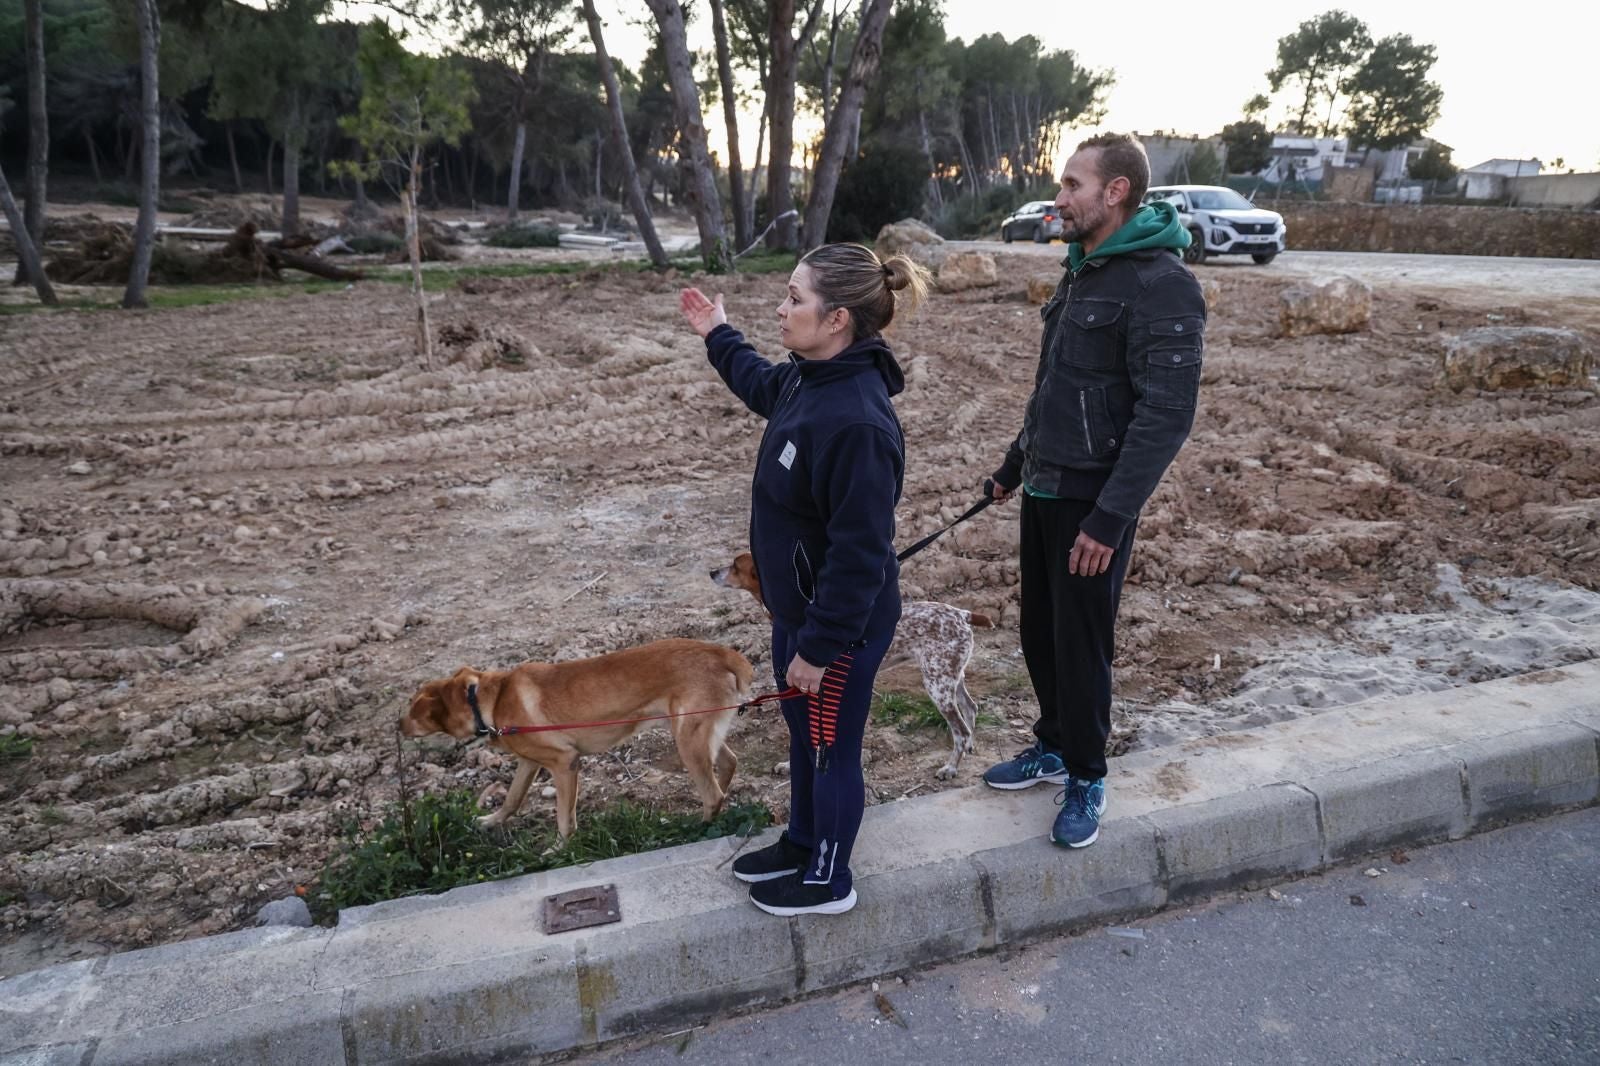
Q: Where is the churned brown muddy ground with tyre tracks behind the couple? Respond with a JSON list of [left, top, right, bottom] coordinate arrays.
[[0, 222, 1600, 973]]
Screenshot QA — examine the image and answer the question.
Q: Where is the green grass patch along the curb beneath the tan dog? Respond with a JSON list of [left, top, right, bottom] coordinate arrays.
[[310, 789, 771, 917]]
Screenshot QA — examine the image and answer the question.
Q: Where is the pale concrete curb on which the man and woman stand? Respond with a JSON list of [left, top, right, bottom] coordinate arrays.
[[0, 661, 1600, 1066]]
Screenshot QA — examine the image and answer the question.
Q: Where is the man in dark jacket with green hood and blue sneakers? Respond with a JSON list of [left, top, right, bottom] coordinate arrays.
[[984, 134, 1205, 848]]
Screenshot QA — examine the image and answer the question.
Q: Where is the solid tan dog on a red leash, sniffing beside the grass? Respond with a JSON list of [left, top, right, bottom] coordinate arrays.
[[400, 640, 754, 840]]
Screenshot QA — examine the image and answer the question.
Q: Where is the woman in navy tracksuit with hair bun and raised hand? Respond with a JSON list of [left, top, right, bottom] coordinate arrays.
[[680, 245, 928, 916]]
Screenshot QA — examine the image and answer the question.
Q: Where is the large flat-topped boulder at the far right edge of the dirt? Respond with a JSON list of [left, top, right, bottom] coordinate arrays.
[[1440, 327, 1594, 392]]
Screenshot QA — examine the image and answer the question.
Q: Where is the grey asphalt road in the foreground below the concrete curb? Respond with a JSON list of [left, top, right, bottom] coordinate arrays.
[[560, 808, 1600, 1066]]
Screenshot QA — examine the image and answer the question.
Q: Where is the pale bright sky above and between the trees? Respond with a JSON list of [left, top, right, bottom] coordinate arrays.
[[344, 0, 1600, 170]]
